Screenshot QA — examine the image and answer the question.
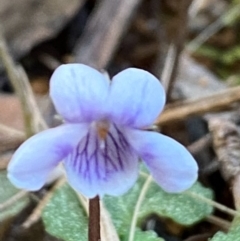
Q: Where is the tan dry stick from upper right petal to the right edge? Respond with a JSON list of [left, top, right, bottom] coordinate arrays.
[[155, 86, 240, 125]]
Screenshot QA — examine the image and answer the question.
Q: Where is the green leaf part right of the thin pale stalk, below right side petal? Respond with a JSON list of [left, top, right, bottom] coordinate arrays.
[[139, 178, 213, 225]]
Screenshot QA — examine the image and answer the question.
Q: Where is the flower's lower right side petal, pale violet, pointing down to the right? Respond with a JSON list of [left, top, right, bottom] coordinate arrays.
[[126, 130, 198, 192]]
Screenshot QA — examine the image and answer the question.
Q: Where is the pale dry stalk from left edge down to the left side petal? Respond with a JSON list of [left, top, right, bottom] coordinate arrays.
[[0, 29, 47, 137]]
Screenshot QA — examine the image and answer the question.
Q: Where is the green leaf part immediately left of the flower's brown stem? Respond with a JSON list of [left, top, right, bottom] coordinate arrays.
[[42, 184, 88, 241]]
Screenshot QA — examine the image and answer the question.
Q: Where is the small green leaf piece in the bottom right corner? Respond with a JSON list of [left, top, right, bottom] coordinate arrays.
[[211, 217, 240, 241]]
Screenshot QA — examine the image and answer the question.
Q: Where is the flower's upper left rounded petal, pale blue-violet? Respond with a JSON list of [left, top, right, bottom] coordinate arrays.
[[50, 64, 109, 123]]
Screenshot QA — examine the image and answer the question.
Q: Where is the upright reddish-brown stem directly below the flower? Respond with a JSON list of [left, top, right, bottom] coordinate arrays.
[[88, 196, 101, 241]]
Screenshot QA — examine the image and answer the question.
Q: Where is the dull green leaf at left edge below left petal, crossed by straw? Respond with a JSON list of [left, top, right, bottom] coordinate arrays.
[[0, 171, 29, 221]]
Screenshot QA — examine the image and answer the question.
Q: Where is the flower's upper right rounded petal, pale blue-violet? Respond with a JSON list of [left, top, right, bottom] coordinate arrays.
[[109, 68, 165, 127]]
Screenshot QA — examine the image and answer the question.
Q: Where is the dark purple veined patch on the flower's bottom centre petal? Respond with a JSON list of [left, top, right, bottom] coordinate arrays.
[[67, 124, 132, 183]]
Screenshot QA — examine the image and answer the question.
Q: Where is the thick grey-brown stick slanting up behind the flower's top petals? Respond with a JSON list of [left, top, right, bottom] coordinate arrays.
[[74, 0, 141, 69]]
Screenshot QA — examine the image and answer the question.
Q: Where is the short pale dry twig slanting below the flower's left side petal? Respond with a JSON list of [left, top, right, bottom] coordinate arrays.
[[22, 178, 66, 229]]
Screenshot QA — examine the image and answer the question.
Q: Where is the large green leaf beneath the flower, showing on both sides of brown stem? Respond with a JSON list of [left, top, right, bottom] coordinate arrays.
[[42, 176, 212, 241]]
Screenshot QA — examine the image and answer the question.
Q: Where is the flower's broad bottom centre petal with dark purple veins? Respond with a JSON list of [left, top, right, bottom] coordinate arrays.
[[64, 126, 138, 198]]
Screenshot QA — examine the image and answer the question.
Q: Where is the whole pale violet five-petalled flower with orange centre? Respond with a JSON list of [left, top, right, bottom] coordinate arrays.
[[8, 64, 198, 198]]
